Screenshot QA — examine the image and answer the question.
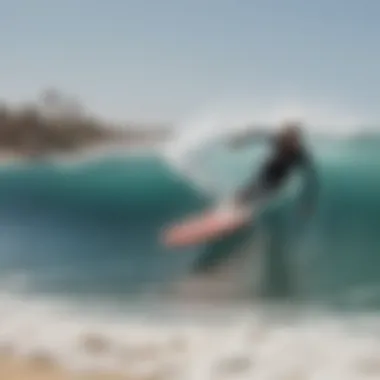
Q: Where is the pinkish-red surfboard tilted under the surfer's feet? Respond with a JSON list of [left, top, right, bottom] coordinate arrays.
[[163, 204, 252, 247]]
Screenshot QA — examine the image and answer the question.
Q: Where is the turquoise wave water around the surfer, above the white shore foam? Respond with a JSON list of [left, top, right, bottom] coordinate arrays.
[[0, 140, 380, 306]]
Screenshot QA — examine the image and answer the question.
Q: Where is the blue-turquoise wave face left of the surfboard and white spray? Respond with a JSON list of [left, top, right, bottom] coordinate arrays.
[[0, 157, 206, 296]]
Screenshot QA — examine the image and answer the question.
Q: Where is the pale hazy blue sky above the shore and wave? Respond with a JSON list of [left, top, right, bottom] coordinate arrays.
[[0, 0, 380, 123]]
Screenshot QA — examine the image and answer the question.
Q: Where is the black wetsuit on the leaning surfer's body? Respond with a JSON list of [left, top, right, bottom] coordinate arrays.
[[238, 144, 311, 202]]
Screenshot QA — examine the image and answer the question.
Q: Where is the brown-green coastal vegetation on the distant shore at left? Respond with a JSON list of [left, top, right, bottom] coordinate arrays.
[[0, 89, 169, 157]]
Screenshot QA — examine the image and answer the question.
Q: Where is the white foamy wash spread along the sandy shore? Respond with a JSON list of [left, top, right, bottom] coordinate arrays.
[[0, 293, 380, 380]]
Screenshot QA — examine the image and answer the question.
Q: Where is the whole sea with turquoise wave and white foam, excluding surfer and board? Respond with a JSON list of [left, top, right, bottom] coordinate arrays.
[[0, 129, 380, 380]]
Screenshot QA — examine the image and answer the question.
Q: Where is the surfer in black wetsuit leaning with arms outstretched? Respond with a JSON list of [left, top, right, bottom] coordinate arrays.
[[232, 123, 318, 217]]
